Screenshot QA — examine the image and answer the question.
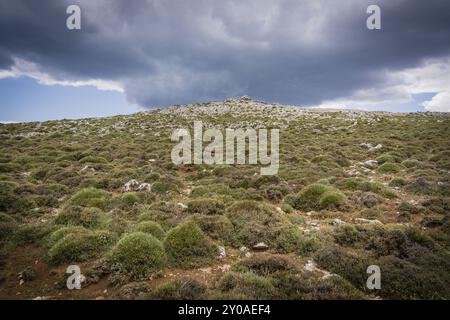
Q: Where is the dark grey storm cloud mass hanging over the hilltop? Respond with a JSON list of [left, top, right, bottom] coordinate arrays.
[[0, 0, 450, 106]]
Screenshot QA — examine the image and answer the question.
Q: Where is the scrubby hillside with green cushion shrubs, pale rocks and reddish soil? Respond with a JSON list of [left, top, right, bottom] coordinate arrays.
[[0, 97, 450, 299]]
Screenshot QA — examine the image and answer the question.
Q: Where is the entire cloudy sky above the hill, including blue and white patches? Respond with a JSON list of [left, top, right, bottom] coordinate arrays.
[[0, 0, 450, 121]]
